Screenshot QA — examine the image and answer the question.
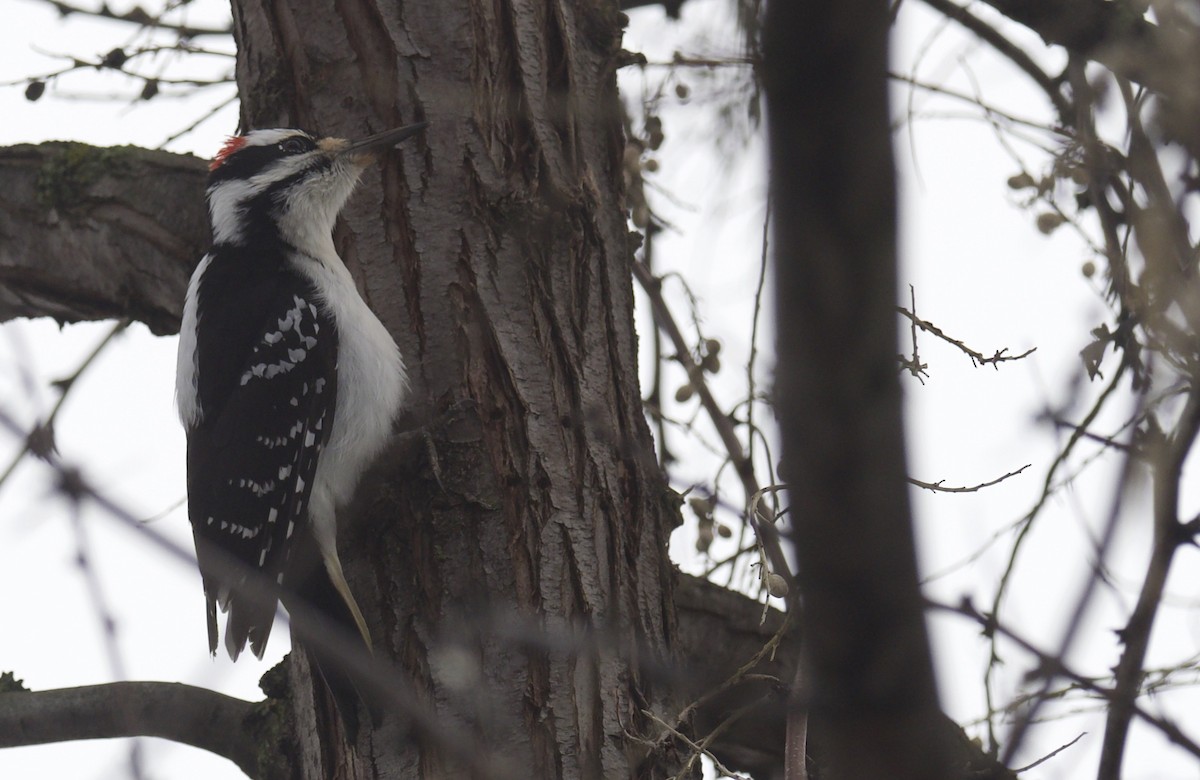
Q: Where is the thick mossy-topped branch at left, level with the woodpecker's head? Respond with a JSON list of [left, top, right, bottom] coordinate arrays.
[[0, 143, 209, 334]]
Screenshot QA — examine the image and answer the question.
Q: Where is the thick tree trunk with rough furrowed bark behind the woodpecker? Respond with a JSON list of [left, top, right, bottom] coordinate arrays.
[[225, 0, 678, 779]]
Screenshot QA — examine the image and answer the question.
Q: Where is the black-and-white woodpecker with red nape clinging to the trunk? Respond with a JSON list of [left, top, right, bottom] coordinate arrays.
[[176, 122, 425, 722]]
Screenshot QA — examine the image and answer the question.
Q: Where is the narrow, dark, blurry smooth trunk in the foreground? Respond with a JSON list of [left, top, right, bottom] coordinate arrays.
[[764, 0, 960, 780]]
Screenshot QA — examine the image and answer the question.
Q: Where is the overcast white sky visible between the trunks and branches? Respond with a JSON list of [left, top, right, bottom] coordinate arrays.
[[0, 0, 1200, 780]]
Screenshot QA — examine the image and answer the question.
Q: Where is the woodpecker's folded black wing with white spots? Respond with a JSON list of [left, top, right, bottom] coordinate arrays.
[[187, 250, 337, 659]]
